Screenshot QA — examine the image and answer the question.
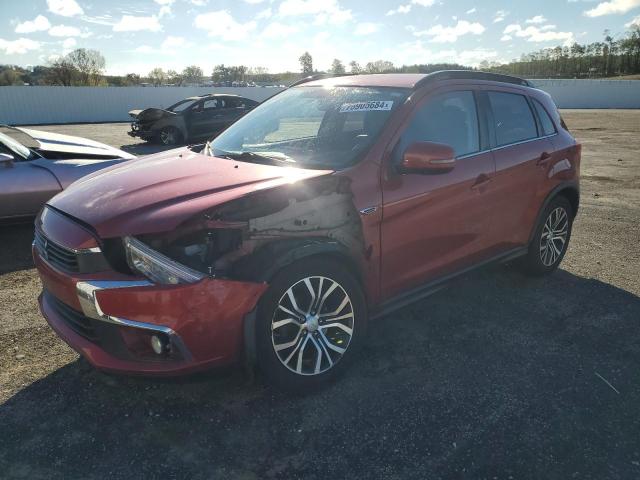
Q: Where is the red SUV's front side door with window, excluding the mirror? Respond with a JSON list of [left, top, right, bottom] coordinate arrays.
[[381, 90, 495, 300]]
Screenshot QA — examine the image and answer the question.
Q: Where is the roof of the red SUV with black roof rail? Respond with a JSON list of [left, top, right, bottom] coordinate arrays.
[[294, 70, 531, 89]]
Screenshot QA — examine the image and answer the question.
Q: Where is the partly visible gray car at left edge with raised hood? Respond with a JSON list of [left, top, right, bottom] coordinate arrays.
[[0, 125, 136, 223]]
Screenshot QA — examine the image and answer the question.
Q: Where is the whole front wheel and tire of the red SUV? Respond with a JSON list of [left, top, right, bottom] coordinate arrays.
[[256, 257, 367, 393]]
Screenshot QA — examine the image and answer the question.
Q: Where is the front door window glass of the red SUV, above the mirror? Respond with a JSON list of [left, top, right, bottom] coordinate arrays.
[[399, 91, 480, 157]]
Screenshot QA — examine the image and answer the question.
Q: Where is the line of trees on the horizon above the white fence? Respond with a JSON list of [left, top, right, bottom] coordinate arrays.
[[0, 25, 640, 86]]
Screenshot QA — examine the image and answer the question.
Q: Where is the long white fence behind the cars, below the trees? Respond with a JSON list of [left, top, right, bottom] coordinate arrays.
[[0, 80, 640, 125]]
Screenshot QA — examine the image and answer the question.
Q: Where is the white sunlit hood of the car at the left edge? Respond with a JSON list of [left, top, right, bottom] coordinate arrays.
[[15, 127, 136, 160]]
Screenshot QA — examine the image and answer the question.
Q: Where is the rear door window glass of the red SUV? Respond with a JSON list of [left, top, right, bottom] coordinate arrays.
[[488, 92, 538, 147]]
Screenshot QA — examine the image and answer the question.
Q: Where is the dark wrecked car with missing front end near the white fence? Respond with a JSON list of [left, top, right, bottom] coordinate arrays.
[[128, 94, 258, 145]]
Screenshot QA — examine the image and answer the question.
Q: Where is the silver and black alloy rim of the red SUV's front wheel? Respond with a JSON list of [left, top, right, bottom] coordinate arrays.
[[271, 276, 354, 375]]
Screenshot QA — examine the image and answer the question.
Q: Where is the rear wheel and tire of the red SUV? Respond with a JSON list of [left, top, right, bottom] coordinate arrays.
[[519, 196, 573, 276]]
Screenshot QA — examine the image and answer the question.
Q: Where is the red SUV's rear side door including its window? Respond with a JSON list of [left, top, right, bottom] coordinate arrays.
[[481, 87, 554, 250]]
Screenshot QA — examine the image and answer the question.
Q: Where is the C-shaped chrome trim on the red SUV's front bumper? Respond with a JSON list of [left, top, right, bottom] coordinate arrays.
[[76, 280, 192, 360]]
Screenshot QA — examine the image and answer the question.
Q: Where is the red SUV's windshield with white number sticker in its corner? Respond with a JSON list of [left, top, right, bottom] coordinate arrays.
[[205, 87, 409, 169]]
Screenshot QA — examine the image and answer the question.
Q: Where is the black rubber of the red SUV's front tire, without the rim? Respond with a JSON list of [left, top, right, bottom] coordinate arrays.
[[256, 257, 367, 393]]
